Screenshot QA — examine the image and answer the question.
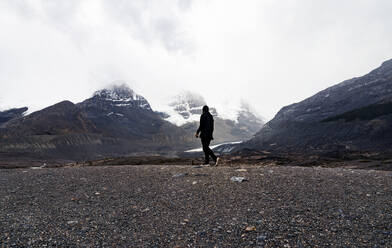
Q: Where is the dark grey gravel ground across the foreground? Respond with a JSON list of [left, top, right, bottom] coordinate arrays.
[[0, 165, 392, 247]]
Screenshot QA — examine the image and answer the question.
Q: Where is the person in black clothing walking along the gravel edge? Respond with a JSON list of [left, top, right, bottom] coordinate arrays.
[[195, 105, 219, 166]]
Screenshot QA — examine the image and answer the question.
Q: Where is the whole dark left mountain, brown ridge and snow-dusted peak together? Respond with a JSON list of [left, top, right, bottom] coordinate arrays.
[[0, 85, 196, 160]]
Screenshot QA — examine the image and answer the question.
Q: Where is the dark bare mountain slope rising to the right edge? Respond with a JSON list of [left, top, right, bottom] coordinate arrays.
[[239, 60, 392, 153]]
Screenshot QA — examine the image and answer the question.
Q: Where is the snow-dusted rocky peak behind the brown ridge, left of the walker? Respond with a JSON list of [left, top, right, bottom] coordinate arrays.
[[77, 84, 193, 145]]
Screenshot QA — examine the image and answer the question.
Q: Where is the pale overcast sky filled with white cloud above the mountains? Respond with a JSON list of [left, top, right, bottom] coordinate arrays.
[[0, 0, 392, 118]]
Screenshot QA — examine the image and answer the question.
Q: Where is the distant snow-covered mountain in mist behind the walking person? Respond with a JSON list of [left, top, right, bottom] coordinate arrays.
[[161, 92, 264, 143]]
